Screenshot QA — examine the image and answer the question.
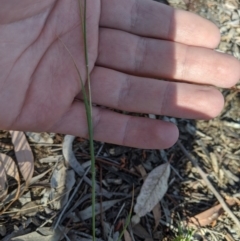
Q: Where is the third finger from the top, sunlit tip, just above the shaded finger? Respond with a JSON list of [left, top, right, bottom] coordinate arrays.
[[79, 67, 224, 119]]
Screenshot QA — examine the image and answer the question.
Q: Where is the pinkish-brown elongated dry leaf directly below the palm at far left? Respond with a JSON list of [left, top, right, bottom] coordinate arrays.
[[10, 131, 34, 186]]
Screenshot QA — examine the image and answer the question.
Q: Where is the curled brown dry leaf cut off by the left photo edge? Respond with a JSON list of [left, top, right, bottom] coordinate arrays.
[[0, 153, 20, 214]]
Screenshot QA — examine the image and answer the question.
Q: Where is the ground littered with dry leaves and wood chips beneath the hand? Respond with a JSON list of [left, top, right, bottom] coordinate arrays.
[[0, 0, 240, 241]]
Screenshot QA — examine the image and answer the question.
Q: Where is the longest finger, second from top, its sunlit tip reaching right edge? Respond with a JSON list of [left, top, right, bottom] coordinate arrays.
[[97, 29, 240, 87]]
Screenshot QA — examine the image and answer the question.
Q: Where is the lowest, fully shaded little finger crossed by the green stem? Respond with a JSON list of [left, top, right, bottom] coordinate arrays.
[[51, 102, 178, 149]]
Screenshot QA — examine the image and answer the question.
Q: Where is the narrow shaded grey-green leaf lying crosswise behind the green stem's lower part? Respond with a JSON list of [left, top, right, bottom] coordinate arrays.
[[79, 199, 122, 221]]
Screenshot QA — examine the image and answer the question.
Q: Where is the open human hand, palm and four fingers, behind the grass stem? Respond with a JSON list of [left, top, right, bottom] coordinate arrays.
[[0, 0, 240, 149]]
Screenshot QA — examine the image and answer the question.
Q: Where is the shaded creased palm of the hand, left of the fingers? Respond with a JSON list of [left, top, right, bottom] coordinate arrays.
[[0, 1, 100, 131]]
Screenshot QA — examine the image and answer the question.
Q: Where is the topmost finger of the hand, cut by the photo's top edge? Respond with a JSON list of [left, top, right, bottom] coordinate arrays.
[[100, 0, 220, 48]]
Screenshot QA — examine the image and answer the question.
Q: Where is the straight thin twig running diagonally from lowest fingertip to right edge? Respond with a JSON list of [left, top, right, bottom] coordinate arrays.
[[177, 141, 240, 232]]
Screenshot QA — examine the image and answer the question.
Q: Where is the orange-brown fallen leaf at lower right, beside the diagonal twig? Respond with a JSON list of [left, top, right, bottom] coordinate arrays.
[[188, 199, 236, 227]]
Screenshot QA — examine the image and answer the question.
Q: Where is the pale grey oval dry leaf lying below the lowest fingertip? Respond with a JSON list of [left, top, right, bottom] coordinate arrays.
[[134, 163, 170, 217]]
